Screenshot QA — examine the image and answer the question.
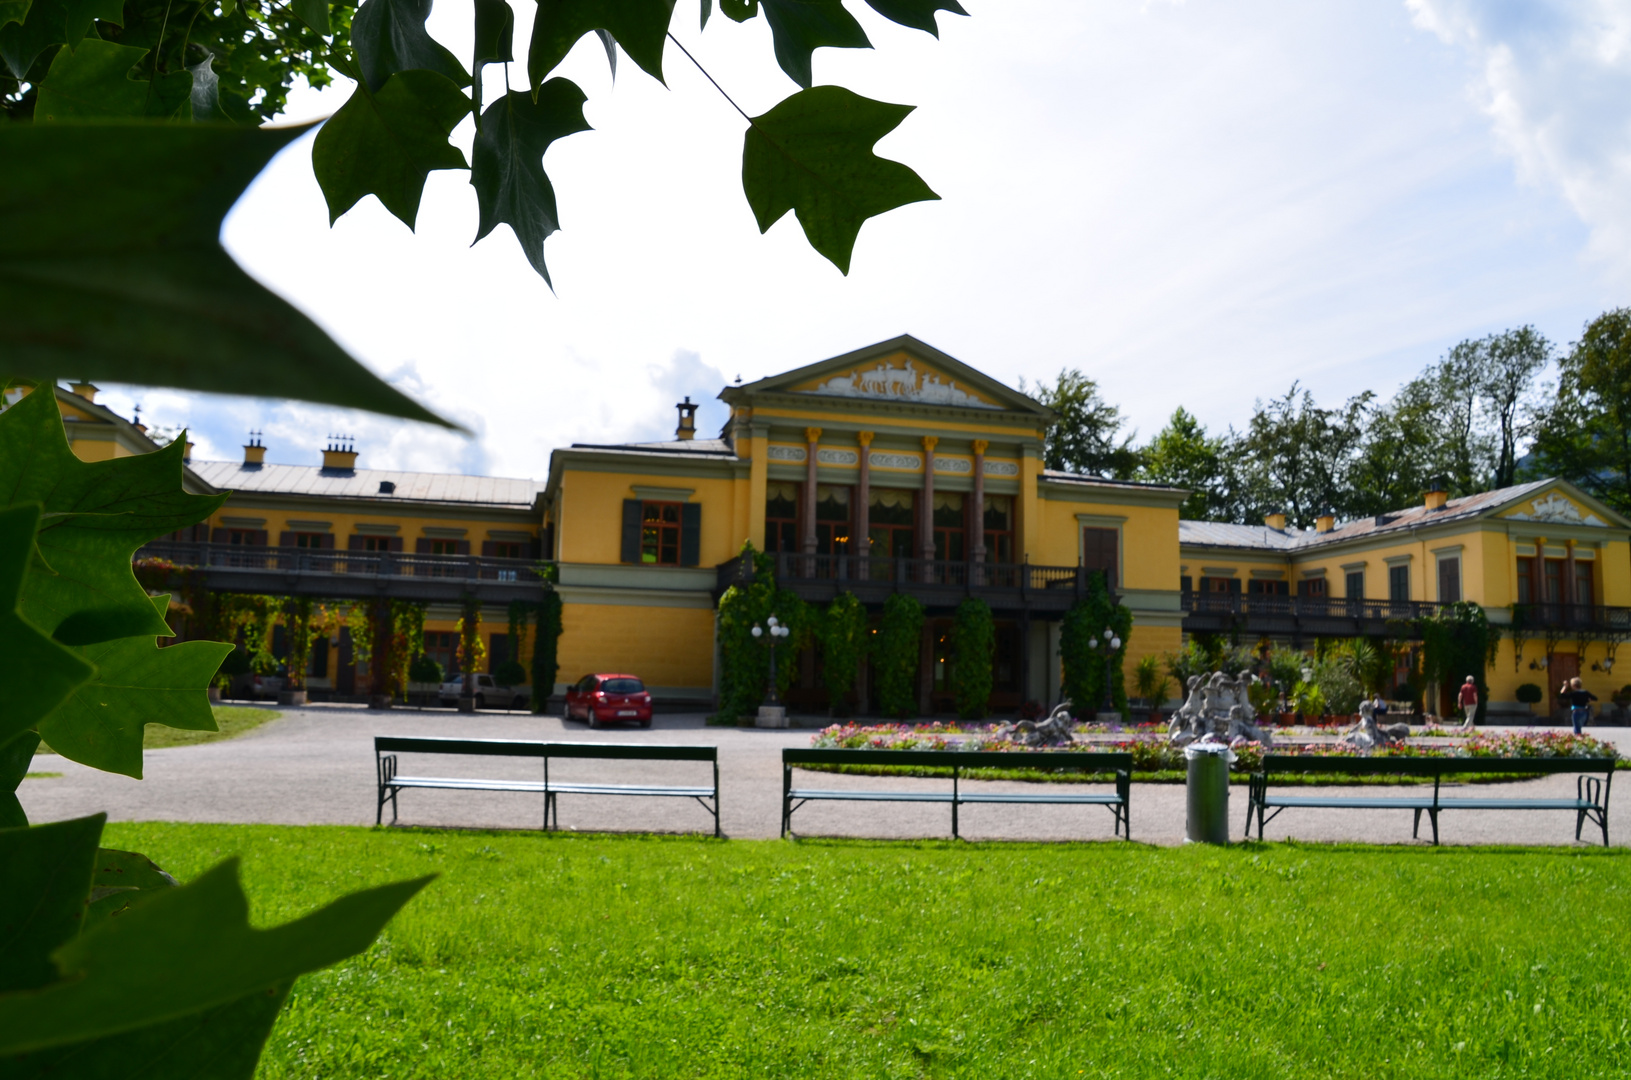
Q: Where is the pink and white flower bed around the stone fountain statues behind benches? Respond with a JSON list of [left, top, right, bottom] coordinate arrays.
[[806, 724, 1620, 785]]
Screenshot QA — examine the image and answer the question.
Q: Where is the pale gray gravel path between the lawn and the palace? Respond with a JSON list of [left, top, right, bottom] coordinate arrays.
[[18, 705, 1631, 847]]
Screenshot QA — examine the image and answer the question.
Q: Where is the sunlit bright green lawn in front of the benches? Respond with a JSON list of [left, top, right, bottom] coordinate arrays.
[[104, 824, 1631, 1080]]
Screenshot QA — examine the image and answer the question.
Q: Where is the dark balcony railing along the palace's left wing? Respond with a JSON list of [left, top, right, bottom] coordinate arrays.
[[135, 542, 543, 584]]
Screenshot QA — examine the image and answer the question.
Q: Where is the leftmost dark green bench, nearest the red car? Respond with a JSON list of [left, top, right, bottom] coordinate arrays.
[[373, 736, 719, 837]]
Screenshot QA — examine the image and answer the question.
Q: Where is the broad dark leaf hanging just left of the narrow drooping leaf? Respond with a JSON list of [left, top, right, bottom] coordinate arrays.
[[312, 70, 470, 228]]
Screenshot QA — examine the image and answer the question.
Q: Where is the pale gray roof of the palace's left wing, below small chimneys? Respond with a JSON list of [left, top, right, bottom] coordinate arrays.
[[192, 462, 543, 507]]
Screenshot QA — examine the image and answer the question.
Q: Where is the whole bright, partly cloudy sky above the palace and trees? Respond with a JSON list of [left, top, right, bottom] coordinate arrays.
[[95, 0, 1631, 478]]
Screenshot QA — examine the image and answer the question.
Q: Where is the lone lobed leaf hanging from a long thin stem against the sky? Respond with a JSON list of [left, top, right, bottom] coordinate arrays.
[[742, 86, 939, 274]]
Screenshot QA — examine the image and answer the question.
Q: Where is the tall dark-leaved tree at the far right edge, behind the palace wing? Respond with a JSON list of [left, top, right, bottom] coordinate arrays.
[[1525, 308, 1631, 512]]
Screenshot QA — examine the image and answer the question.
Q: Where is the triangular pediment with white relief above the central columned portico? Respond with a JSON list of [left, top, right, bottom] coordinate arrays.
[[721, 334, 1052, 418]]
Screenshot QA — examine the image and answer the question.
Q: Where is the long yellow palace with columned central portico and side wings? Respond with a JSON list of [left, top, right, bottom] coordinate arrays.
[[44, 336, 1631, 715]]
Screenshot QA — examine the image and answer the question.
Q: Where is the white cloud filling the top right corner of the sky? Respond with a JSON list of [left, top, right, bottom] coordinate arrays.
[[1406, 0, 1631, 284]]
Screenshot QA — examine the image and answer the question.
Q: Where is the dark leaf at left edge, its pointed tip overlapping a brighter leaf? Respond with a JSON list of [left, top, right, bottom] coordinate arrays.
[[0, 506, 95, 753]]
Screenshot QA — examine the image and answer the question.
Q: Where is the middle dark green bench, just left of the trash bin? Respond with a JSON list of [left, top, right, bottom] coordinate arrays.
[[781, 749, 1132, 840]]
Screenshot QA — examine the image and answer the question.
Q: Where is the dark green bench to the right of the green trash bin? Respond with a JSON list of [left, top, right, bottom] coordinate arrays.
[[1246, 754, 1615, 847]]
